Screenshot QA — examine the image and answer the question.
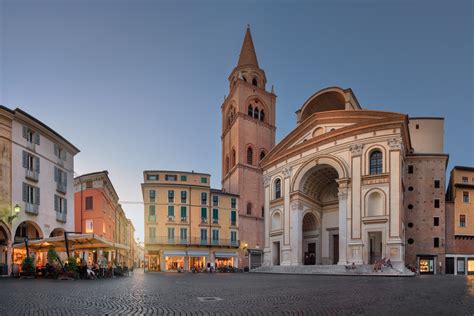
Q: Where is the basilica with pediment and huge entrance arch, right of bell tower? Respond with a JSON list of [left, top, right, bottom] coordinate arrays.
[[261, 87, 447, 266]]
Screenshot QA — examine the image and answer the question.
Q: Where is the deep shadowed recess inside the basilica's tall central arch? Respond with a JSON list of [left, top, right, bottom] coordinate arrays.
[[300, 164, 339, 264]]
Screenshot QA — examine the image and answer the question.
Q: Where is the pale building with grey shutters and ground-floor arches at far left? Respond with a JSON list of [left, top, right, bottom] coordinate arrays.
[[0, 107, 79, 276]]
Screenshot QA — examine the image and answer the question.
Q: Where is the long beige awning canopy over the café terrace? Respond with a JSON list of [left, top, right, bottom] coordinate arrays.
[[13, 234, 129, 251]]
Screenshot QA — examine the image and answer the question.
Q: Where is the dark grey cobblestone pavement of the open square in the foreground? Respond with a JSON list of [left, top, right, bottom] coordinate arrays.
[[0, 271, 474, 315]]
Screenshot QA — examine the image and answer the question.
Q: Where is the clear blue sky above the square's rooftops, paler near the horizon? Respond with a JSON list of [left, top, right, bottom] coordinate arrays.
[[0, 0, 474, 240]]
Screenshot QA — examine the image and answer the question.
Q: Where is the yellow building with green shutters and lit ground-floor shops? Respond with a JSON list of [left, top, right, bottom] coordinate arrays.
[[142, 170, 239, 271]]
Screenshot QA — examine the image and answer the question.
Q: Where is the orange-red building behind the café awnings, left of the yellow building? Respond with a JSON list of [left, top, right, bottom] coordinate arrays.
[[74, 171, 135, 267]]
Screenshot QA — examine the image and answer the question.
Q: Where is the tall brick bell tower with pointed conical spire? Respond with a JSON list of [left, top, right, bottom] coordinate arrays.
[[221, 26, 276, 267]]
